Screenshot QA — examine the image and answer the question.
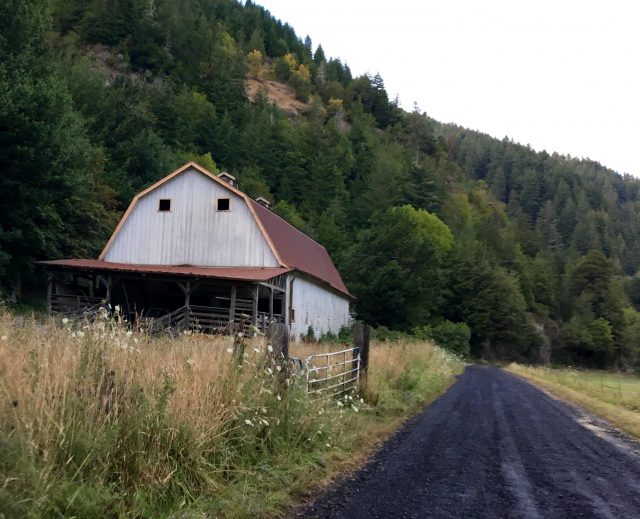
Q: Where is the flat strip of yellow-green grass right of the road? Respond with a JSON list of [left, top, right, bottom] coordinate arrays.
[[507, 364, 640, 438]]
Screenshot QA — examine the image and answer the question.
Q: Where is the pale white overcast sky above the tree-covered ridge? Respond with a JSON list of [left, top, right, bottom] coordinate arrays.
[[258, 0, 640, 176]]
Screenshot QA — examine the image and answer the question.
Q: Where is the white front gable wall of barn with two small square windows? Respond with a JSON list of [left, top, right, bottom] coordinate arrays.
[[104, 170, 279, 267]]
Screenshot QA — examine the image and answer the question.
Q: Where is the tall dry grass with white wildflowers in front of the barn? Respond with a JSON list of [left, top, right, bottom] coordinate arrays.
[[0, 311, 463, 517]]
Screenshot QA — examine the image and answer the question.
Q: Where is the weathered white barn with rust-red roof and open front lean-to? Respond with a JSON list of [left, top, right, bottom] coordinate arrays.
[[40, 162, 353, 337]]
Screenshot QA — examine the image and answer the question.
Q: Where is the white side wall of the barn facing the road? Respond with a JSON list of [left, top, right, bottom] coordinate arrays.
[[289, 274, 350, 338]]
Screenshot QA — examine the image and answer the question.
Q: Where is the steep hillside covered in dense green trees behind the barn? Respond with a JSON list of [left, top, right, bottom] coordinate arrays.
[[0, 0, 640, 367]]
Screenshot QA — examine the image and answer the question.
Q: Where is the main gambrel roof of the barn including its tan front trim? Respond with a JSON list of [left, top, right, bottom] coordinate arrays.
[[99, 162, 351, 297]]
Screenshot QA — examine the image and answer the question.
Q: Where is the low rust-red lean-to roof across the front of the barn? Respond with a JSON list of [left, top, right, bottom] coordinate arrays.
[[38, 259, 291, 281]]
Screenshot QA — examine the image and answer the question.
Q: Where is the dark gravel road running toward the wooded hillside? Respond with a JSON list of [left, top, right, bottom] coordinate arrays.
[[300, 366, 640, 519]]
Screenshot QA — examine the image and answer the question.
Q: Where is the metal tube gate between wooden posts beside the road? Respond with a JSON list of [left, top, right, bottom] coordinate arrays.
[[292, 347, 360, 398]]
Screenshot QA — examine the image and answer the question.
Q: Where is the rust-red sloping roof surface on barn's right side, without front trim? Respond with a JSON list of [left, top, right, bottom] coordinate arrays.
[[247, 197, 351, 296]]
